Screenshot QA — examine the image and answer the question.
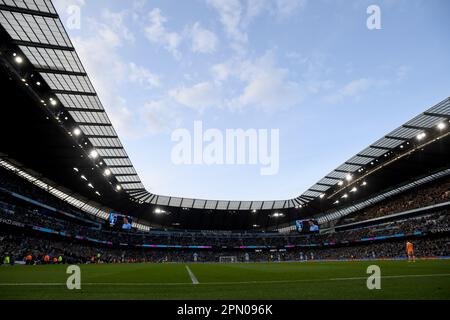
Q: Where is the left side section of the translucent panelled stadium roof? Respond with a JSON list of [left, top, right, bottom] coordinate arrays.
[[0, 0, 144, 192]]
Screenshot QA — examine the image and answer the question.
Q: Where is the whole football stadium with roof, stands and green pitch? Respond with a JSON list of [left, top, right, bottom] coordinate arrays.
[[0, 0, 450, 300]]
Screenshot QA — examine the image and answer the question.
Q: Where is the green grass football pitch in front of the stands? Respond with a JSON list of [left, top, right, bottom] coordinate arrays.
[[0, 260, 450, 300]]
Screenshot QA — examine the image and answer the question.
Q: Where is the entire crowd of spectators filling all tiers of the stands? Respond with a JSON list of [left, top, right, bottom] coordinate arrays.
[[0, 165, 450, 263]]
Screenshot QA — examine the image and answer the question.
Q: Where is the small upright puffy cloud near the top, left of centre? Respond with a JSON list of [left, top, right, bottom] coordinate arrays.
[[145, 8, 182, 58]]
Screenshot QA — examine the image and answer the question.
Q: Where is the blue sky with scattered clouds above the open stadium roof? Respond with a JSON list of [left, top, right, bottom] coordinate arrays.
[[54, 0, 450, 200]]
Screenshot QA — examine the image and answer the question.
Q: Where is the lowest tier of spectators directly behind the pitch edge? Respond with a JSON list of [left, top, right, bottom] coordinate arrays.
[[0, 233, 450, 264]]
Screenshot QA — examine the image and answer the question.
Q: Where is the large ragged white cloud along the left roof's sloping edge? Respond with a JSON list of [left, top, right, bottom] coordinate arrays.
[[73, 12, 164, 137]]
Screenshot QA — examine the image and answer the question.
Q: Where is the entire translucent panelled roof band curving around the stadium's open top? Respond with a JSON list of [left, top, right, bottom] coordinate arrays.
[[0, 0, 450, 215]]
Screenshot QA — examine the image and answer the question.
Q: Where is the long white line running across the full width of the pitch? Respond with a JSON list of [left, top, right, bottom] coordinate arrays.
[[0, 274, 450, 287]]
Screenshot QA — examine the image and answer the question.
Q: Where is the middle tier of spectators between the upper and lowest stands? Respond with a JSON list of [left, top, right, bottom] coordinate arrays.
[[0, 195, 450, 248]]
